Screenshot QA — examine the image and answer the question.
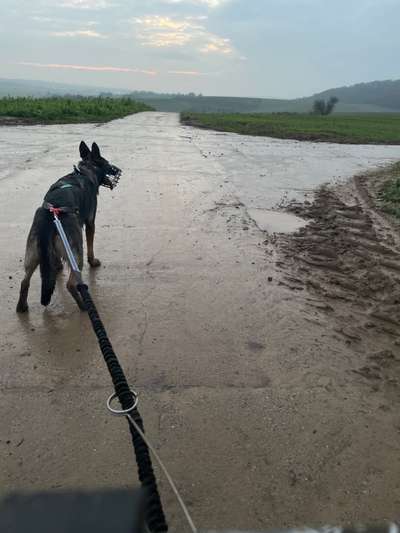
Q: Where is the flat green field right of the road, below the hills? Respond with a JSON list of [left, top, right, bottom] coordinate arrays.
[[181, 112, 400, 144]]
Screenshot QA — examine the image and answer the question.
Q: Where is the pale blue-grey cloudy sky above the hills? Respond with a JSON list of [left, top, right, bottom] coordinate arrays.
[[0, 0, 400, 98]]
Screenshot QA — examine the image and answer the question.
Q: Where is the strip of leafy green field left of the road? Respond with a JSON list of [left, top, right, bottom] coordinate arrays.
[[0, 97, 152, 124]]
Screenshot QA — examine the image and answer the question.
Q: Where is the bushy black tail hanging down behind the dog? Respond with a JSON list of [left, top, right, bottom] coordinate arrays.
[[38, 207, 57, 305]]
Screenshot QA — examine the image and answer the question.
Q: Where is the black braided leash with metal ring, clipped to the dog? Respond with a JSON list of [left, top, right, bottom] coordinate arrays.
[[48, 205, 197, 533]]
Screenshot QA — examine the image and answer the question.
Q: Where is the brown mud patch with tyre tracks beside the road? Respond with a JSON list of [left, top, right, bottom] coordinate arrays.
[[272, 171, 400, 399]]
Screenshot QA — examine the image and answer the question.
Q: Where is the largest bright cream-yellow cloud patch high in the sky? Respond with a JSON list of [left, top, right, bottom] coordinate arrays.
[[132, 15, 234, 55]]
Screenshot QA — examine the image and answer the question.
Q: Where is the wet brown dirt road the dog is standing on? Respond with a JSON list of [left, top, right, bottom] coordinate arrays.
[[0, 113, 400, 529]]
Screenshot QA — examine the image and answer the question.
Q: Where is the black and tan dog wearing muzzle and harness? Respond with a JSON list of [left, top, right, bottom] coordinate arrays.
[[17, 141, 122, 313]]
